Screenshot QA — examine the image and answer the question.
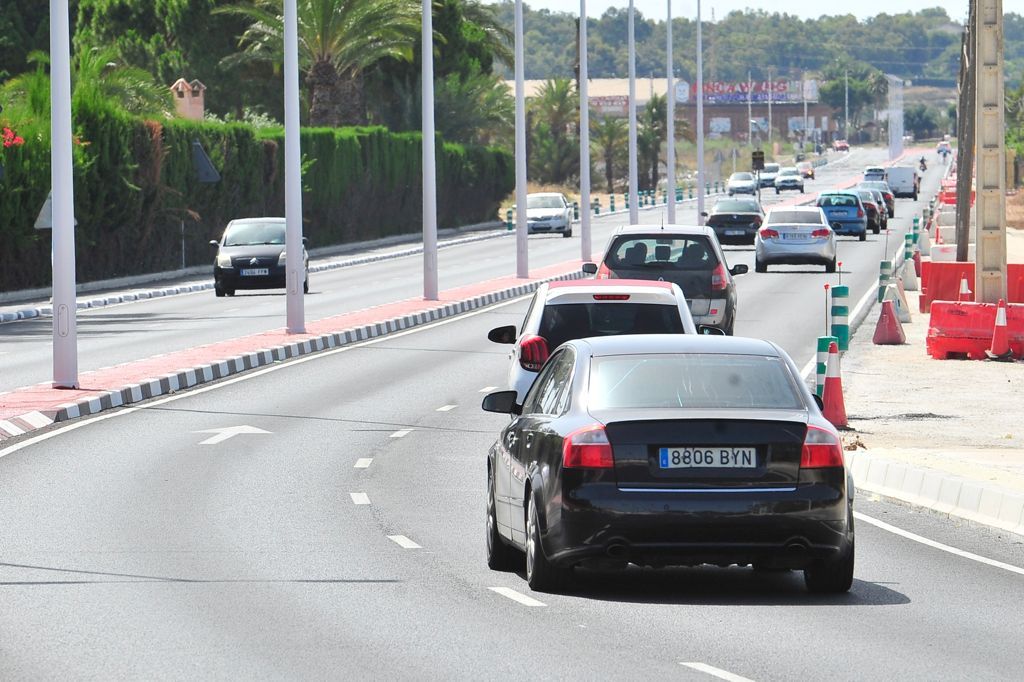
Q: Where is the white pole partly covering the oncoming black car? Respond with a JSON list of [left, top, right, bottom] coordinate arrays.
[[285, 0, 306, 334]]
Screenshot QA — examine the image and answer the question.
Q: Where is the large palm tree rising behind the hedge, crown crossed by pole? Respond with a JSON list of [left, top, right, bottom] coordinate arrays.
[[215, 0, 420, 126]]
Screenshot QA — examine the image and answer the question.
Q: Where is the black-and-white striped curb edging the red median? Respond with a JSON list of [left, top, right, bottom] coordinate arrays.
[[0, 270, 587, 442]]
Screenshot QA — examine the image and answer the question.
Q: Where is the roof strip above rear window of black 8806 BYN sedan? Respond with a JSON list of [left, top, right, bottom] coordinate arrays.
[[570, 334, 782, 357]]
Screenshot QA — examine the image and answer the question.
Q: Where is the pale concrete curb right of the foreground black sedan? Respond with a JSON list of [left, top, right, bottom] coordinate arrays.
[[849, 452, 1024, 536]]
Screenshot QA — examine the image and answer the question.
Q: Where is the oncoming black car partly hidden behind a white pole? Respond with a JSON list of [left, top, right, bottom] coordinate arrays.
[[210, 218, 309, 296]]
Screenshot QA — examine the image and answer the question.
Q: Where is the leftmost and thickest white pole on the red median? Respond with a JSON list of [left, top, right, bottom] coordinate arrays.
[[50, 0, 78, 388]]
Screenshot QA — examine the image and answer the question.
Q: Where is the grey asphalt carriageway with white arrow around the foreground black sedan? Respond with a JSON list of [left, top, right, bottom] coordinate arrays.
[[0, 300, 1024, 680]]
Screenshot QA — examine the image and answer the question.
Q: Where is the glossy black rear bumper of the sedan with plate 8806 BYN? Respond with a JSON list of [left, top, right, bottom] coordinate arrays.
[[543, 483, 853, 568]]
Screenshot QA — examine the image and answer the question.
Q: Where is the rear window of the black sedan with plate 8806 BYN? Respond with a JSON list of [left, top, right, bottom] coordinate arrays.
[[588, 353, 805, 410]]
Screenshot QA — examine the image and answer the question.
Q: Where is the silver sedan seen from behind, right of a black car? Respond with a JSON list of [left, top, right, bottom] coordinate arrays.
[[754, 206, 836, 272]]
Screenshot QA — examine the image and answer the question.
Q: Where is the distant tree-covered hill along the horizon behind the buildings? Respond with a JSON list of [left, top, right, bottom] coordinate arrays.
[[495, 2, 1024, 87]]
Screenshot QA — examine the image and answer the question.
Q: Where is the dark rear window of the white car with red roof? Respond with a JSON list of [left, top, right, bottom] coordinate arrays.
[[540, 302, 685, 349]]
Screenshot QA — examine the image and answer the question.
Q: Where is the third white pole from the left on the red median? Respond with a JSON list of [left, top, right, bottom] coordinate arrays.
[[420, 0, 437, 301]]
